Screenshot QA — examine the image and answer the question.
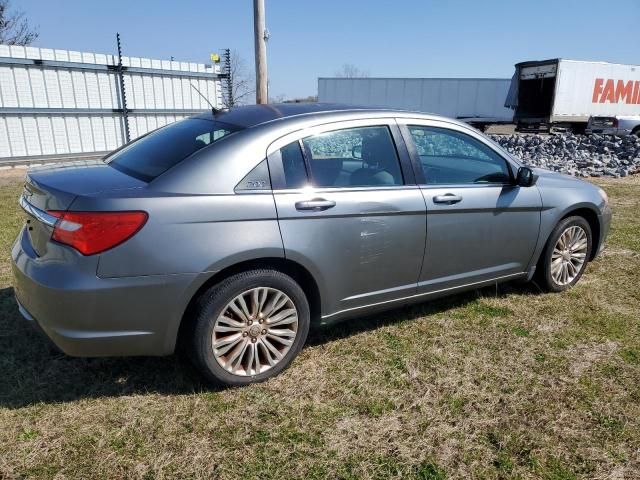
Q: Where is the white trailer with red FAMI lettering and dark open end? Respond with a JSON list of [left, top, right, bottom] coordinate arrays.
[[507, 59, 640, 130]]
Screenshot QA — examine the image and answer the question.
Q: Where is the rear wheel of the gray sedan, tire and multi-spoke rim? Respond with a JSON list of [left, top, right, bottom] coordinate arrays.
[[189, 270, 310, 386]]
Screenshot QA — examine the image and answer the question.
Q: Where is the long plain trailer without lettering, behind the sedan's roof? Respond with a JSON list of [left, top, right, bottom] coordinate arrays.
[[318, 78, 513, 123]]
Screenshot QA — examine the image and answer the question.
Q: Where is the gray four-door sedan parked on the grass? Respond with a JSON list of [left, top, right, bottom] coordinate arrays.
[[12, 104, 611, 385]]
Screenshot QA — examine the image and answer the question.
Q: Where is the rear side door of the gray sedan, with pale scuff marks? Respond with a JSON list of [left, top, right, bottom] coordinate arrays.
[[267, 119, 426, 321]]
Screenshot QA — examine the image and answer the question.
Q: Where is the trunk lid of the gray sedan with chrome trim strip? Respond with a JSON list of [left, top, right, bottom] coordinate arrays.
[[20, 160, 146, 256]]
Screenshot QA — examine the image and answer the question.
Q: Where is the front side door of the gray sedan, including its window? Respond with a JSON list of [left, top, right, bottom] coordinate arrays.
[[399, 119, 542, 293]]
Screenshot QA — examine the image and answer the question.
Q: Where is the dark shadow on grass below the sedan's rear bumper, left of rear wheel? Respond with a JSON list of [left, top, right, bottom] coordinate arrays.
[[0, 288, 216, 408]]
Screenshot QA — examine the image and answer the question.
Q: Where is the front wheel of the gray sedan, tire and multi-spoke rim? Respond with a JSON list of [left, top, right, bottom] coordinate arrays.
[[537, 216, 592, 292]]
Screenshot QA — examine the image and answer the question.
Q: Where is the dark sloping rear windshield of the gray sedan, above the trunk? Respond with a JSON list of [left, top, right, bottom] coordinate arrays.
[[105, 118, 242, 182]]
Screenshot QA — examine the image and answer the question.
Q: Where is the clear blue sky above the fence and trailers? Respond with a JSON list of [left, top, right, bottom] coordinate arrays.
[[13, 0, 640, 98]]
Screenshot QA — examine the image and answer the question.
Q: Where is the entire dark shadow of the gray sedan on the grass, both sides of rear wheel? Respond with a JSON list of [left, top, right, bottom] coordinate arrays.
[[0, 285, 538, 408]]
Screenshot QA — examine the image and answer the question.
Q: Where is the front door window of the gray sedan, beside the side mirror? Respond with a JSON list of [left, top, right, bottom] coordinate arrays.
[[409, 125, 511, 185]]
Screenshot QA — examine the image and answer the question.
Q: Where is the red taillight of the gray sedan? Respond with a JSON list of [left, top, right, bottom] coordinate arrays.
[[49, 211, 149, 255]]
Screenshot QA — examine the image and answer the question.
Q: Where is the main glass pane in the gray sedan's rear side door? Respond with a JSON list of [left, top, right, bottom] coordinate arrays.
[[302, 126, 403, 187]]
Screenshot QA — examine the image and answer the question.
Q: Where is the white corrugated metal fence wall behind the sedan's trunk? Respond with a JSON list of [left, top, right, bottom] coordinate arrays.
[[0, 45, 222, 162]]
